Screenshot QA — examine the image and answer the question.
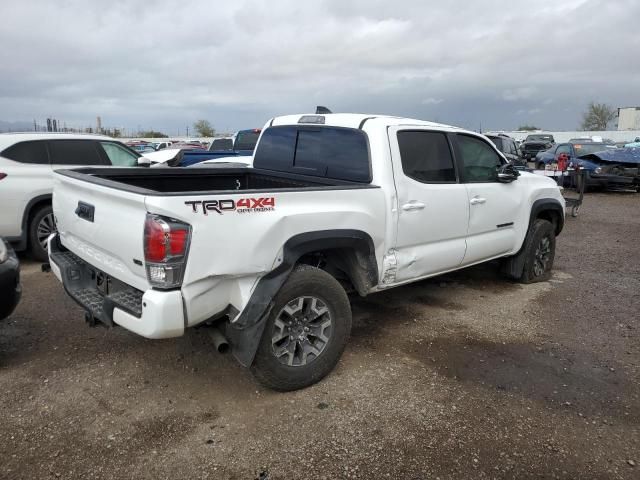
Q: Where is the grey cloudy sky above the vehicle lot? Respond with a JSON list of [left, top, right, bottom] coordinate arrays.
[[0, 0, 640, 135]]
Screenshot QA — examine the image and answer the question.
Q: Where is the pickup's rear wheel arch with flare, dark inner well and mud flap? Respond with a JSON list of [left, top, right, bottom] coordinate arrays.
[[225, 229, 378, 367]]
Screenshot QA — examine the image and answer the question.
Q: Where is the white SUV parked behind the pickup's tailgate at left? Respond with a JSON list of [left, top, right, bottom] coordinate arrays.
[[0, 132, 146, 261]]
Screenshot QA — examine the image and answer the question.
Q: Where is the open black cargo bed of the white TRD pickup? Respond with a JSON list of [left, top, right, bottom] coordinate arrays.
[[57, 167, 372, 195]]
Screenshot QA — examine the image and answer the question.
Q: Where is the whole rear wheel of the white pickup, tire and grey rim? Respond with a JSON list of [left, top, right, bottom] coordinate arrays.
[[251, 265, 351, 391]]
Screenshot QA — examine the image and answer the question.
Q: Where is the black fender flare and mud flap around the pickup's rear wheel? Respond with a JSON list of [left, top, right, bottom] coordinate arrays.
[[225, 229, 378, 367]]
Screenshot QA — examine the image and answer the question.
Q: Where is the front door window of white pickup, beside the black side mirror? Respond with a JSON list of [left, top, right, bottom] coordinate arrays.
[[453, 134, 504, 183]]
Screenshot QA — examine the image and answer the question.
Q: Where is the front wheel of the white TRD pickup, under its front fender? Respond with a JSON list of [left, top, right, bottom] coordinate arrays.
[[518, 219, 556, 283]]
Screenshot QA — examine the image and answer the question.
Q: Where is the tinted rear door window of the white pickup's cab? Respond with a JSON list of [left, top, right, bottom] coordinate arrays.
[[398, 130, 457, 183]]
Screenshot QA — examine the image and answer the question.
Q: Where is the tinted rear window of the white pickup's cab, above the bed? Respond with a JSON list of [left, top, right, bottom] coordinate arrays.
[[253, 126, 371, 183]]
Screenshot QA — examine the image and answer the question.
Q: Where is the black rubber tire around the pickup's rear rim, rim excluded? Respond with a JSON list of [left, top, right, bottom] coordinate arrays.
[[251, 265, 351, 392]]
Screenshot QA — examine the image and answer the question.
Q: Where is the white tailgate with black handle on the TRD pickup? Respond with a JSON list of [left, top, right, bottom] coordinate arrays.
[[53, 173, 150, 291]]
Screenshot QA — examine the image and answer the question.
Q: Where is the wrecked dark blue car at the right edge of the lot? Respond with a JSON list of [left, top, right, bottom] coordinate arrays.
[[535, 142, 640, 191]]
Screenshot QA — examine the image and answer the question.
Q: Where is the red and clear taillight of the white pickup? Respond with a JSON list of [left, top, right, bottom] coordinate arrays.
[[144, 214, 191, 288]]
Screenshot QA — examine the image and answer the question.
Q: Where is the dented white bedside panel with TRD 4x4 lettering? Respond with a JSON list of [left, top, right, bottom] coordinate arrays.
[[146, 188, 385, 326]]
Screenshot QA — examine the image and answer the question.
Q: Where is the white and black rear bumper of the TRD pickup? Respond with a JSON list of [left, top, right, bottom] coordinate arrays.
[[49, 235, 185, 338]]
